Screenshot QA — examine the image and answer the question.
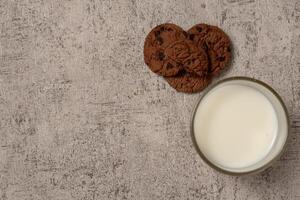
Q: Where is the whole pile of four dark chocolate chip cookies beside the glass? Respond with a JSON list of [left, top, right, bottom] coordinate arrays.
[[144, 23, 231, 93]]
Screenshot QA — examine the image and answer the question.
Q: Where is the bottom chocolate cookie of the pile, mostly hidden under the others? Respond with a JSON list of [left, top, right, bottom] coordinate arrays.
[[165, 71, 211, 93]]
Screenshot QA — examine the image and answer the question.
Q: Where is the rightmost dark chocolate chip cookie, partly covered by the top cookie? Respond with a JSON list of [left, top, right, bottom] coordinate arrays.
[[187, 24, 231, 75]]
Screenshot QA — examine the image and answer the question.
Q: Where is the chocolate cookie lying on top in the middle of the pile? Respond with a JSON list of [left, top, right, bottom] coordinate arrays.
[[165, 39, 209, 76]]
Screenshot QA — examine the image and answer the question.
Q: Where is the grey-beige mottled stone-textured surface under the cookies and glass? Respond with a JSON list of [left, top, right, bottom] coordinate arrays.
[[0, 0, 300, 200]]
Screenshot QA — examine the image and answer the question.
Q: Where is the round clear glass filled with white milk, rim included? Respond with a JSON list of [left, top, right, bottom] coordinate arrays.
[[191, 77, 289, 175]]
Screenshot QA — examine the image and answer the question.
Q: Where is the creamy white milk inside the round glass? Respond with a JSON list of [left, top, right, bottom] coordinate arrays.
[[194, 84, 278, 169]]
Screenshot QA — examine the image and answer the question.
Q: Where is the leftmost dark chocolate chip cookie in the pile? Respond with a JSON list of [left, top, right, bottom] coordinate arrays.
[[144, 23, 186, 76]]
